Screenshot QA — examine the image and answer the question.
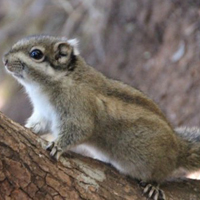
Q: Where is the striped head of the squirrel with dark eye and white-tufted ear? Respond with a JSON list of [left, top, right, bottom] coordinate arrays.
[[3, 35, 79, 84]]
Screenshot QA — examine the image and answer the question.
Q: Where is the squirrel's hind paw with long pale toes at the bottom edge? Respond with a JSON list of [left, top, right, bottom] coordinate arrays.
[[139, 181, 166, 200]]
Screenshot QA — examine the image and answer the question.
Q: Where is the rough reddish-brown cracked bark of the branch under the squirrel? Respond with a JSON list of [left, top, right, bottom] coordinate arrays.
[[0, 113, 200, 200]]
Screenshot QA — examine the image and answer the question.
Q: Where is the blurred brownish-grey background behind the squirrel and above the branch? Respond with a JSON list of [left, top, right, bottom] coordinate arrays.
[[0, 0, 200, 126]]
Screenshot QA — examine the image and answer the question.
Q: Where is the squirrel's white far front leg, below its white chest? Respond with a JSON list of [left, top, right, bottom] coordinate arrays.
[[25, 112, 48, 135]]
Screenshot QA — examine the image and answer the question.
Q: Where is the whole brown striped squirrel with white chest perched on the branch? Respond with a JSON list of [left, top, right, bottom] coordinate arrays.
[[3, 35, 200, 200]]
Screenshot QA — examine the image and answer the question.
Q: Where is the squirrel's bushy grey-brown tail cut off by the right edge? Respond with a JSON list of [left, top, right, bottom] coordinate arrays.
[[175, 127, 200, 171]]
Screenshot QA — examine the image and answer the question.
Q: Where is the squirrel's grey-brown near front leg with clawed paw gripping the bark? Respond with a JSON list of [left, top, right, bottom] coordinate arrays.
[[46, 120, 93, 160]]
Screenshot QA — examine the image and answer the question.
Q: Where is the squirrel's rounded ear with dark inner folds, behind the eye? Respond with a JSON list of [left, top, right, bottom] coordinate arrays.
[[54, 42, 73, 64]]
